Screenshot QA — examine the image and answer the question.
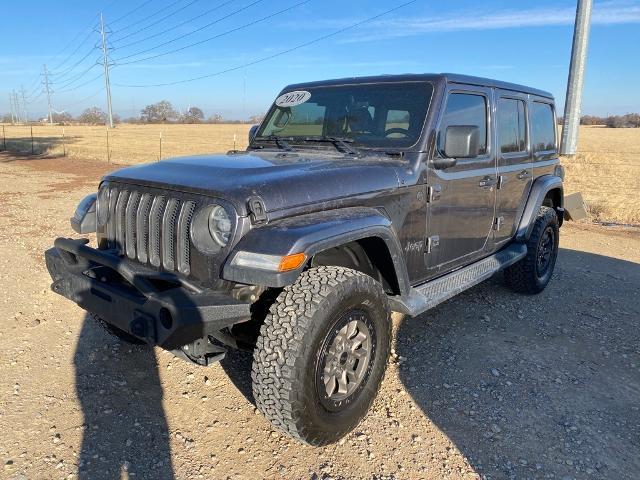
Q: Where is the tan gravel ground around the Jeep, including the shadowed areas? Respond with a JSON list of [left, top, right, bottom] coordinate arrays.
[[0, 156, 640, 480]]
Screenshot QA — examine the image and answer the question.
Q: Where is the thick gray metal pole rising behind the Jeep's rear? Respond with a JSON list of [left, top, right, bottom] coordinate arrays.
[[560, 0, 593, 155]]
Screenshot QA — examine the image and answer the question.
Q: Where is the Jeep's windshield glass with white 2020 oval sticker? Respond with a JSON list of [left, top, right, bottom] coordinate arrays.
[[256, 82, 433, 148]]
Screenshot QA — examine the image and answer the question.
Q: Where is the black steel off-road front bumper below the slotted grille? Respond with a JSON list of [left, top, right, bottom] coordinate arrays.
[[45, 238, 250, 350]]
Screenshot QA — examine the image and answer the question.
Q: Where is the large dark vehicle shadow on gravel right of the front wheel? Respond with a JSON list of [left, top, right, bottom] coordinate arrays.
[[396, 249, 640, 480]]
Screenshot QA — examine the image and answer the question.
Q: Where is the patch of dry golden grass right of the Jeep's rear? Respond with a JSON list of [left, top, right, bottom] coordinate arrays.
[[562, 127, 640, 224]]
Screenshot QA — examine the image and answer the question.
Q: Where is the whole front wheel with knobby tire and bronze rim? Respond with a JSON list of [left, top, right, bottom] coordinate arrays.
[[252, 267, 391, 445]]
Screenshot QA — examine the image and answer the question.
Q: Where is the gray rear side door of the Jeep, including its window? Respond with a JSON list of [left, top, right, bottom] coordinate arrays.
[[494, 90, 533, 247]]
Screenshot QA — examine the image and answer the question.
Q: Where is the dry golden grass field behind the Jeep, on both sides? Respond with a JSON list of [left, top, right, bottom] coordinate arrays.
[[1, 124, 640, 223]]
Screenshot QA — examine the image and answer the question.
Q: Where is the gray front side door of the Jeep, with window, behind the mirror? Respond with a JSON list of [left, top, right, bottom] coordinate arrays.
[[425, 86, 497, 276]]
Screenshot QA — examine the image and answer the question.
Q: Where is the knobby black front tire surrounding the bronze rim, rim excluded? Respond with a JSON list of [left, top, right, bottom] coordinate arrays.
[[251, 266, 391, 446]]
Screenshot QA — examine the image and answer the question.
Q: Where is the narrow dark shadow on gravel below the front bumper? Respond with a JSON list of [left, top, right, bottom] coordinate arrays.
[[74, 315, 174, 480]]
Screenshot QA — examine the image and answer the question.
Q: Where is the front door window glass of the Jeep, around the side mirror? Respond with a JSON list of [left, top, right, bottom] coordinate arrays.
[[438, 93, 487, 155]]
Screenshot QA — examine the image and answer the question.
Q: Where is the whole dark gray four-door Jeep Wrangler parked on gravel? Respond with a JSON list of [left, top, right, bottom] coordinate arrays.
[[46, 74, 564, 445]]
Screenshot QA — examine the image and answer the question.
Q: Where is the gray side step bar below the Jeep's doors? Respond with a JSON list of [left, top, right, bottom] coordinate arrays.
[[389, 243, 527, 317]]
